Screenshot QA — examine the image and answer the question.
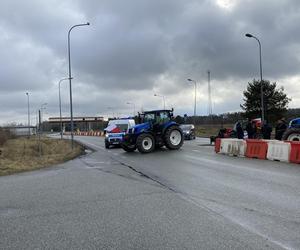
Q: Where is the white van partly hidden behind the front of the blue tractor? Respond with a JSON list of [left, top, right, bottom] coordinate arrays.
[[104, 119, 135, 149]]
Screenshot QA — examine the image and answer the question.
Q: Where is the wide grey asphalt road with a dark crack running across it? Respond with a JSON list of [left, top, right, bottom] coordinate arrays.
[[0, 137, 300, 249]]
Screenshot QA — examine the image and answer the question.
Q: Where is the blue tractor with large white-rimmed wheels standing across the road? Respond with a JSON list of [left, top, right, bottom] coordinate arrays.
[[121, 110, 184, 153]]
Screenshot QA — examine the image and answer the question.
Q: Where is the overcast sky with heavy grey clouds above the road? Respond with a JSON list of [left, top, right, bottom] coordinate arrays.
[[0, 0, 300, 124]]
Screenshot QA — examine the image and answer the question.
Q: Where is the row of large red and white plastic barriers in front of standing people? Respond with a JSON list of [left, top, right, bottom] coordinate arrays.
[[215, 138, 300, 164]]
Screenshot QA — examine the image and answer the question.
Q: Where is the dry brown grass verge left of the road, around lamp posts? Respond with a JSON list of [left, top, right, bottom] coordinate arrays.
[[0, 137, 84, 176]]
